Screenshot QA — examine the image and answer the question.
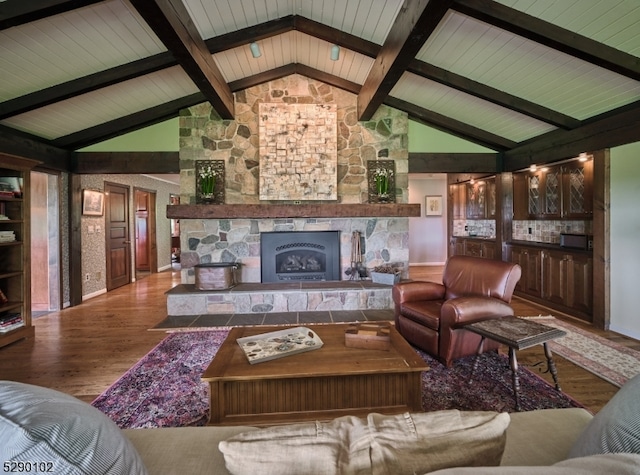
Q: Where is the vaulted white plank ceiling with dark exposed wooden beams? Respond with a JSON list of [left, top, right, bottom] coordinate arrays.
[[0, 0, 640, 171]]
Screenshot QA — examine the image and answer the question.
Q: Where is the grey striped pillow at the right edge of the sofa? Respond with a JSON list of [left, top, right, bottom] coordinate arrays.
[[569, 374, 640, 458]]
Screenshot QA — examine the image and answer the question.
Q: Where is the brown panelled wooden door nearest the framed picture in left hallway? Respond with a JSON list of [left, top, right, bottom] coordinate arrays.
[[104, 183, 131, 290]]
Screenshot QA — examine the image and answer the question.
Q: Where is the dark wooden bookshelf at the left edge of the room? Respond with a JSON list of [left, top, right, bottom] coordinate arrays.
[[0, 154, 36, 347]]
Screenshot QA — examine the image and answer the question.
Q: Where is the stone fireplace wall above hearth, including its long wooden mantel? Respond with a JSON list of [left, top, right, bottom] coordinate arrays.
[[167, 74, 412, 313]]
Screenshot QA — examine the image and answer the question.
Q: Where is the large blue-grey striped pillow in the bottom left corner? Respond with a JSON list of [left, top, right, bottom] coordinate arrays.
[[0, 381, 147, 475]]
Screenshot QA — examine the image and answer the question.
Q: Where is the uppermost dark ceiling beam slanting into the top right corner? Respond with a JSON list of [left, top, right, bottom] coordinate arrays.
[[452, 0, 640, 81]]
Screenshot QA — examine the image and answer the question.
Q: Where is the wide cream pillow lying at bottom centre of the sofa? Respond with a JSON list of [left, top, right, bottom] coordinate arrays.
[[219, 410, 510, 475]]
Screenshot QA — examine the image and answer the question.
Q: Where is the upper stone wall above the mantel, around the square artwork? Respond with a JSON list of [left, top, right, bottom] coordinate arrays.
[[180, 74, 409, 204]]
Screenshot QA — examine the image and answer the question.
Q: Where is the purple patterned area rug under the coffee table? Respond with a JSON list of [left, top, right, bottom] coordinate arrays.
[[92, 329, 582, 428]]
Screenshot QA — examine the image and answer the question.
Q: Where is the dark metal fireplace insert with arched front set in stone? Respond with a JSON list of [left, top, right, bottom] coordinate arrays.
[[260, 231, 340, 282]]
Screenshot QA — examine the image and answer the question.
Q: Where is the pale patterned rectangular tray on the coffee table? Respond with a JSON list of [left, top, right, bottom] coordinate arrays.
[[237, 327, 323, 364]]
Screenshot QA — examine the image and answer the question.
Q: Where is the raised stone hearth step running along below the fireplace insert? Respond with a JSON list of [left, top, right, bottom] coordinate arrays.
[[167, 280, 393, 316]]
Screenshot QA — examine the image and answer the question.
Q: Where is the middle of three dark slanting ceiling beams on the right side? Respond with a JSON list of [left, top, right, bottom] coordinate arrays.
[[407, 59, 581, 130]]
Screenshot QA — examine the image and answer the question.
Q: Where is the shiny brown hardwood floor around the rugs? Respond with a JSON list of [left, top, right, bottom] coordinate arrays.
[[0, 267, 640, 412]]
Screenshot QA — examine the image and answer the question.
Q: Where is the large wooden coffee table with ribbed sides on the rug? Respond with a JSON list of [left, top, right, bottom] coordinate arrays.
[[202, 324, 429, 425]]
